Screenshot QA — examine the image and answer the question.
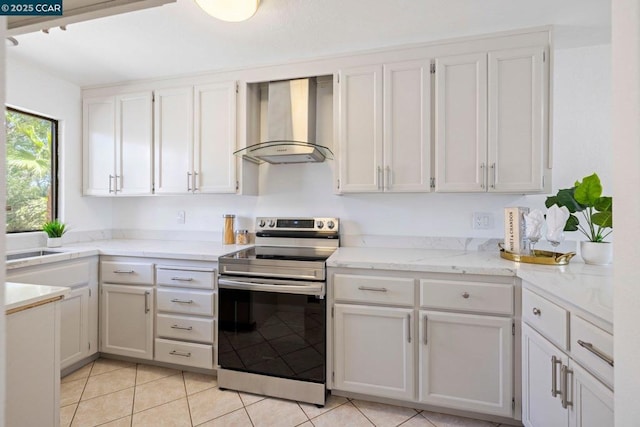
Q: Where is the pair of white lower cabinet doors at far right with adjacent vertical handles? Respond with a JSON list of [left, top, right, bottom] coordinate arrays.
[[522, 324, 614, 427]]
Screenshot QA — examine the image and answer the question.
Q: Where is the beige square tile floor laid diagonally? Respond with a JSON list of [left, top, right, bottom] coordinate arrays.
[[60, 359, 516, 427]]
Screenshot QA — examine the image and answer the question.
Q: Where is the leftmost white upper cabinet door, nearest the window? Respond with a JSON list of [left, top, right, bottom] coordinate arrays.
[[82, 97, 116, 196]]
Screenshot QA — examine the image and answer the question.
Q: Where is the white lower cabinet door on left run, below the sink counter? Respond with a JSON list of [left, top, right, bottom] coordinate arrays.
[[60, 286, 89, 369]]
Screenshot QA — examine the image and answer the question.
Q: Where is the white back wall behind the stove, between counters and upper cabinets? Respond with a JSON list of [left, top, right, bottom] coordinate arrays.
[[113, 45, 613, 244]]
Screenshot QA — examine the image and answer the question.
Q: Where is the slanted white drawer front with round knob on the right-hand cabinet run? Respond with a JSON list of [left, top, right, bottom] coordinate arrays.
[[522, 289, 568, 350]]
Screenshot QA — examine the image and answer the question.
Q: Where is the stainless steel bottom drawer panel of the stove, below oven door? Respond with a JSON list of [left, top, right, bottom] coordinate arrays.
[[217, 368, 326, 405]]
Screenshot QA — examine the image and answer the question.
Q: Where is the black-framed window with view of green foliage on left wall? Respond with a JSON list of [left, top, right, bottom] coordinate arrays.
[[5, 107, 58, 233]]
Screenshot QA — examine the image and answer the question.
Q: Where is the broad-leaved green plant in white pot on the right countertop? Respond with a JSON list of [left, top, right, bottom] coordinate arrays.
[[545, 173, 613, 265]]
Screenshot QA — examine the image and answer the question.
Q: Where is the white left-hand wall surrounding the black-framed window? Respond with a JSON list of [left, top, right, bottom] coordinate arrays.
[[6, 60, 111, 249]]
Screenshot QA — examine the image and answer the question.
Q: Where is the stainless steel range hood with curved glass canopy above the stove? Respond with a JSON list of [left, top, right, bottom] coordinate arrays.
[[234, 78, 333, 164]]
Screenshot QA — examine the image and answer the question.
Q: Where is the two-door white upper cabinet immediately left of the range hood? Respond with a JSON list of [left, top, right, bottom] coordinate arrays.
[[154, 82, 236, 194]]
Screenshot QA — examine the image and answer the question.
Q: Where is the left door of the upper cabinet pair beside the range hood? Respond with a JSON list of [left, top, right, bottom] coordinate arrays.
[[153, 86, 193, 194]]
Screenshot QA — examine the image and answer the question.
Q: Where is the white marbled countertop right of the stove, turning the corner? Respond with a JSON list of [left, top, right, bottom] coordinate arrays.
[[327, 247, 613, 332]]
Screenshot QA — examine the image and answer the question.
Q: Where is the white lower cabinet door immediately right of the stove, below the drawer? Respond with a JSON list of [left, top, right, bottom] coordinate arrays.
[[333, 304, 414, 400]]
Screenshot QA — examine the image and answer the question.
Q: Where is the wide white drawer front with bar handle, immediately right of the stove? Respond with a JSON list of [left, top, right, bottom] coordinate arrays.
[[333, 274, 415, 305]]
